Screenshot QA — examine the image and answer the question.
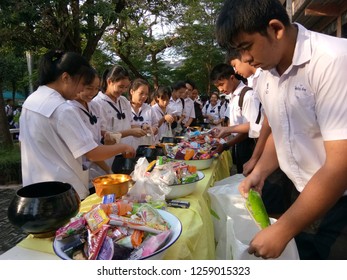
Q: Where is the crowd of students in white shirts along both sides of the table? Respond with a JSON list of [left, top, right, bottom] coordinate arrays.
[[16, 0, 347, 259]]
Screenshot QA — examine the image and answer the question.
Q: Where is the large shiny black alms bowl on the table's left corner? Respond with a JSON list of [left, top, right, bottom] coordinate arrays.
[[7, 181, 81, 236]]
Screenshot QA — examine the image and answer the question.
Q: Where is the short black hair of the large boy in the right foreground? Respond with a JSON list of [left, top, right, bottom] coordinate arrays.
[[216, 0, 290, 49]]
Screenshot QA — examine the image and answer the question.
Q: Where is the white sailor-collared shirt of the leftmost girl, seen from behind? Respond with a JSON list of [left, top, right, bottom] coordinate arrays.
[[19, 86, 98, 199]]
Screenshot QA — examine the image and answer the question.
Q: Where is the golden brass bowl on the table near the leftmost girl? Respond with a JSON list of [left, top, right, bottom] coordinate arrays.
[[92, 174, 133, 198]]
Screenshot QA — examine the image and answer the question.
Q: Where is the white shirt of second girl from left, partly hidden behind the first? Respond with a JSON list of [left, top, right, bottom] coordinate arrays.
[[67, 100, 106, 180]]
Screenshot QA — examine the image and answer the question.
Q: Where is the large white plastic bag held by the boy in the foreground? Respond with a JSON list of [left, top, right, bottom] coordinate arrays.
[[208, 174, 299, 260]]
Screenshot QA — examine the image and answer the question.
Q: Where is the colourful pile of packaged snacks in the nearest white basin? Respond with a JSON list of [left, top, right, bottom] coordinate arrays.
[[55, 199, 171, 260]]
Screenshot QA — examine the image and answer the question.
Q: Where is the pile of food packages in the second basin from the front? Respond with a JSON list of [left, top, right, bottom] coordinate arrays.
[[145, 156, 199, 186]]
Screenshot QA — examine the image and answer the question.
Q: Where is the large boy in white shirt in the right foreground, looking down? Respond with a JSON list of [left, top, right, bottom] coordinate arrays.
[[216, 0, 347, 259]]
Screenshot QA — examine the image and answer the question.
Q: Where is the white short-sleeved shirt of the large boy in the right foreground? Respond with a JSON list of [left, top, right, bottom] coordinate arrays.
[[257, 24, 347, 191]]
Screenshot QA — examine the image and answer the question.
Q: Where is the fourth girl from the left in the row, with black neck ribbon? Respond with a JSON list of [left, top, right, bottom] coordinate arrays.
[[129, 79, 158, 149]]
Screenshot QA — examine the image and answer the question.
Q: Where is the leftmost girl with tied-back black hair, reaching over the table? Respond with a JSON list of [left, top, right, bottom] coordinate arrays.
[[19, 51, 135, 199]]
